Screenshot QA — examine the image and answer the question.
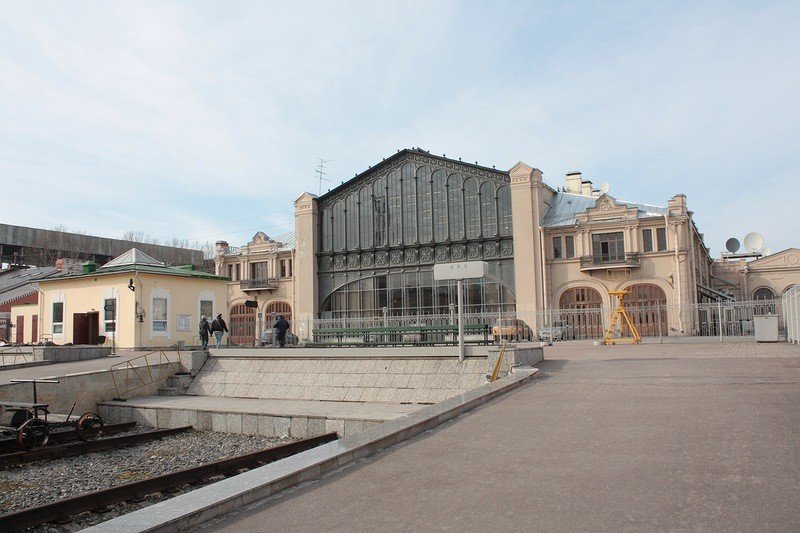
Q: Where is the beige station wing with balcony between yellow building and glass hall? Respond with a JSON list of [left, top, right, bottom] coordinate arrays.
[[215, 231, 295, 346]]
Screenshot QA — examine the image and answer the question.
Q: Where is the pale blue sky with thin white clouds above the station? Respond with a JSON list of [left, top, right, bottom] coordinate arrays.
[[0, 0, 800, 256]]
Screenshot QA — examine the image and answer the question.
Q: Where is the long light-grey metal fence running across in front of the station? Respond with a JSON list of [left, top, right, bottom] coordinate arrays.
[[308, 298, 788, 342]]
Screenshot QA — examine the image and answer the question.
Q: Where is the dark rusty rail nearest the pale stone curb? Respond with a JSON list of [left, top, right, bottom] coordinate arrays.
[[0, 433, 337, 531]]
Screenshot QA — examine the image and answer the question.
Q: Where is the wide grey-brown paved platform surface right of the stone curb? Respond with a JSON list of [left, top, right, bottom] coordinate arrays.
[[202, 344, 800, 533]]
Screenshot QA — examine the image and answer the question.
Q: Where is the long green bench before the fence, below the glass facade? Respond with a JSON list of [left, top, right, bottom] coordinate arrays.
[[312, 324, 491, 346]]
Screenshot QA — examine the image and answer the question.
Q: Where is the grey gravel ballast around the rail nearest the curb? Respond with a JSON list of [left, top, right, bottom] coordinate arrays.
[[0, 430, 294, 531]]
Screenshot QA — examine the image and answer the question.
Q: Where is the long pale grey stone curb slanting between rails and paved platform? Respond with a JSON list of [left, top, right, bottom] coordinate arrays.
[[83, 368, 539, 533]]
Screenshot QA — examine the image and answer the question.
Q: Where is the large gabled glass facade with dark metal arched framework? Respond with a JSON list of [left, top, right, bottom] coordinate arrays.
[[318, 150, 515, 318]]
